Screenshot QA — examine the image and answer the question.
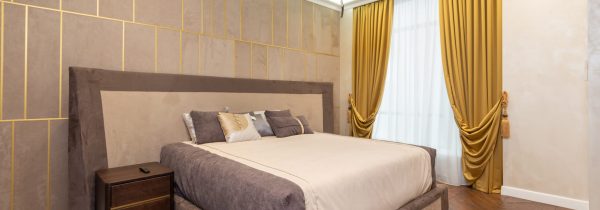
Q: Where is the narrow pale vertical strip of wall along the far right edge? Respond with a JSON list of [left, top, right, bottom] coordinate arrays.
[[588, 0, 600, 210]]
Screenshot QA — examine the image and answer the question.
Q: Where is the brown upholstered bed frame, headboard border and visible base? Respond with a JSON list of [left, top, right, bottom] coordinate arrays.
[[69, 67, 448, 210]]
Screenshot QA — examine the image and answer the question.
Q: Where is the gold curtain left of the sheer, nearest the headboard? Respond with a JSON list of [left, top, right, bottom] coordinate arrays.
[[350, 0, 394, 138]]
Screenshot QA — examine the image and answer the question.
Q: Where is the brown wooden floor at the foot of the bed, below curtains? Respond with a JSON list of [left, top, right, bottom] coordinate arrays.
[[448, 186, 565, 210]]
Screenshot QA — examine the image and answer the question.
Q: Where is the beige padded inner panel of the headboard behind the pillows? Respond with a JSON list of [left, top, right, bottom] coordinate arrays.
[[101, 91, 323, 167]]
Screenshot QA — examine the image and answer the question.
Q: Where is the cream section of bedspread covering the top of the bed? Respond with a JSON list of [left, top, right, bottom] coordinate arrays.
[[188, 133, 432, 210]]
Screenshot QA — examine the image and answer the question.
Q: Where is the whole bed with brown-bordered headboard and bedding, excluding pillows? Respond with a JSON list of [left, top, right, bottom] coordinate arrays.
[[69, 67, 448, 210]]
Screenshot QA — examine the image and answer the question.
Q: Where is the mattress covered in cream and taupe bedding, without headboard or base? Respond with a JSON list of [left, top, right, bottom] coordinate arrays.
[[161, 133, 434, 210]]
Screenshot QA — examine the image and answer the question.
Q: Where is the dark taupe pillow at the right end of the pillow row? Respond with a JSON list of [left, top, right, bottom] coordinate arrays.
[[267, 116, 314, 138]]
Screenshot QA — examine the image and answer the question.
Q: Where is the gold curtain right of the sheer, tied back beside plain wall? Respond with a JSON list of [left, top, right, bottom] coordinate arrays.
[[440, 0, 502, 193]]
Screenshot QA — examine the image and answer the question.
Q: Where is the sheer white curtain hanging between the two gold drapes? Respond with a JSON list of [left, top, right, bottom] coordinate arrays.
[[373, 0, 466, 185]]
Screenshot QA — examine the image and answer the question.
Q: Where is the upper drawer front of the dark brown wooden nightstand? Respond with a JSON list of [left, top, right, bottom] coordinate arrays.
[[111, 176, 172, 208]]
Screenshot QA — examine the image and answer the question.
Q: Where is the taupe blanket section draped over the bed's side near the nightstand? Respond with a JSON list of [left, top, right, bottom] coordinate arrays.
[[160, 143, 305, 210]]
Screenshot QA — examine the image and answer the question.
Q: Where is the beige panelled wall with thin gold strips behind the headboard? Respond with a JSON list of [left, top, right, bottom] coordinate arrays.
[[0, 0, 340, 209]]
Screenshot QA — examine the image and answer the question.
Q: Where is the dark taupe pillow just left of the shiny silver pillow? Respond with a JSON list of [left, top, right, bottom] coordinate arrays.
[[190, 111, 225, 144]]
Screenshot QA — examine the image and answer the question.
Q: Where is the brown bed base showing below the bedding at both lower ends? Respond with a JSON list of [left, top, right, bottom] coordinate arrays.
[[175, 185, 448, 210]]
